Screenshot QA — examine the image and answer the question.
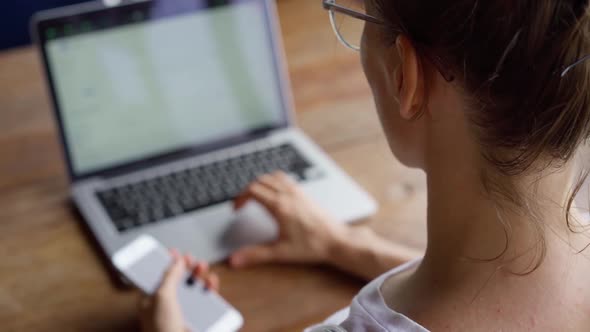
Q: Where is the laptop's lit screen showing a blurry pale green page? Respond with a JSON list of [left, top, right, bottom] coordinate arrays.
[[40, 0, 285, 174]]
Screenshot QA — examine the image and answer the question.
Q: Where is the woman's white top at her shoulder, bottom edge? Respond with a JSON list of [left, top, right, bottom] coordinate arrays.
[[305, 260, 428, 332]]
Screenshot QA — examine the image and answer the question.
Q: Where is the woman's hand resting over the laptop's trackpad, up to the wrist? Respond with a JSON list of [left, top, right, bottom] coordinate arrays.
[[230, 173, 347, 267]]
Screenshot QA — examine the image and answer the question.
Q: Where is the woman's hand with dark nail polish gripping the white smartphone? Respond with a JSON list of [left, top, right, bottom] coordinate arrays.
[[139, 251, 219, 332]]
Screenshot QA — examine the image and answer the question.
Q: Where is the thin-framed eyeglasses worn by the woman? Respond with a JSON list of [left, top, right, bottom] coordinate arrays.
[[323, 0, 455, 82]]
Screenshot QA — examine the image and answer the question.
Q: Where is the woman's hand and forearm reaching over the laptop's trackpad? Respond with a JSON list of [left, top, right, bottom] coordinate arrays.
[[230, 173, 421, 280]]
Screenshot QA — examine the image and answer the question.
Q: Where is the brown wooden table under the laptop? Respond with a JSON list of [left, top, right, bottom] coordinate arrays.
[[0, 0, 426, 331]]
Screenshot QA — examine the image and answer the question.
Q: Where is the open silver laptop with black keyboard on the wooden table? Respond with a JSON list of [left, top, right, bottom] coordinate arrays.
[[32, 0, 377, 262]]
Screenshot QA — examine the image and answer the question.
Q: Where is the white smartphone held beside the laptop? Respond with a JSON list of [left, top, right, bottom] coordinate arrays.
[[112, 235, 244, 332]]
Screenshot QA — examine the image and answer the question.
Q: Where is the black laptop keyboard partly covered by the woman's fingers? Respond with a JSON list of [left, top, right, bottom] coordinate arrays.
[[96, 144, 320, 232]]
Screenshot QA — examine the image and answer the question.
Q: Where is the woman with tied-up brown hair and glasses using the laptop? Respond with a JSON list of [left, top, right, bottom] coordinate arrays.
[[144, 0, 590, 332]]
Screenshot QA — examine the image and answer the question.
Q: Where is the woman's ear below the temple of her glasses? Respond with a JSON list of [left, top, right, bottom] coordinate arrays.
[[396, 35, 425, 120]]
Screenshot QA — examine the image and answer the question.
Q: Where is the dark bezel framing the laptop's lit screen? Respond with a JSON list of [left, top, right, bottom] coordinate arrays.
[[31, 0, 293, 182]]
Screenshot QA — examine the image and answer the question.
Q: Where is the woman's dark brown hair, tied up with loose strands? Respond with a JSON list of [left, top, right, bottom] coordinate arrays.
[[374, 0, 590, 268]]
